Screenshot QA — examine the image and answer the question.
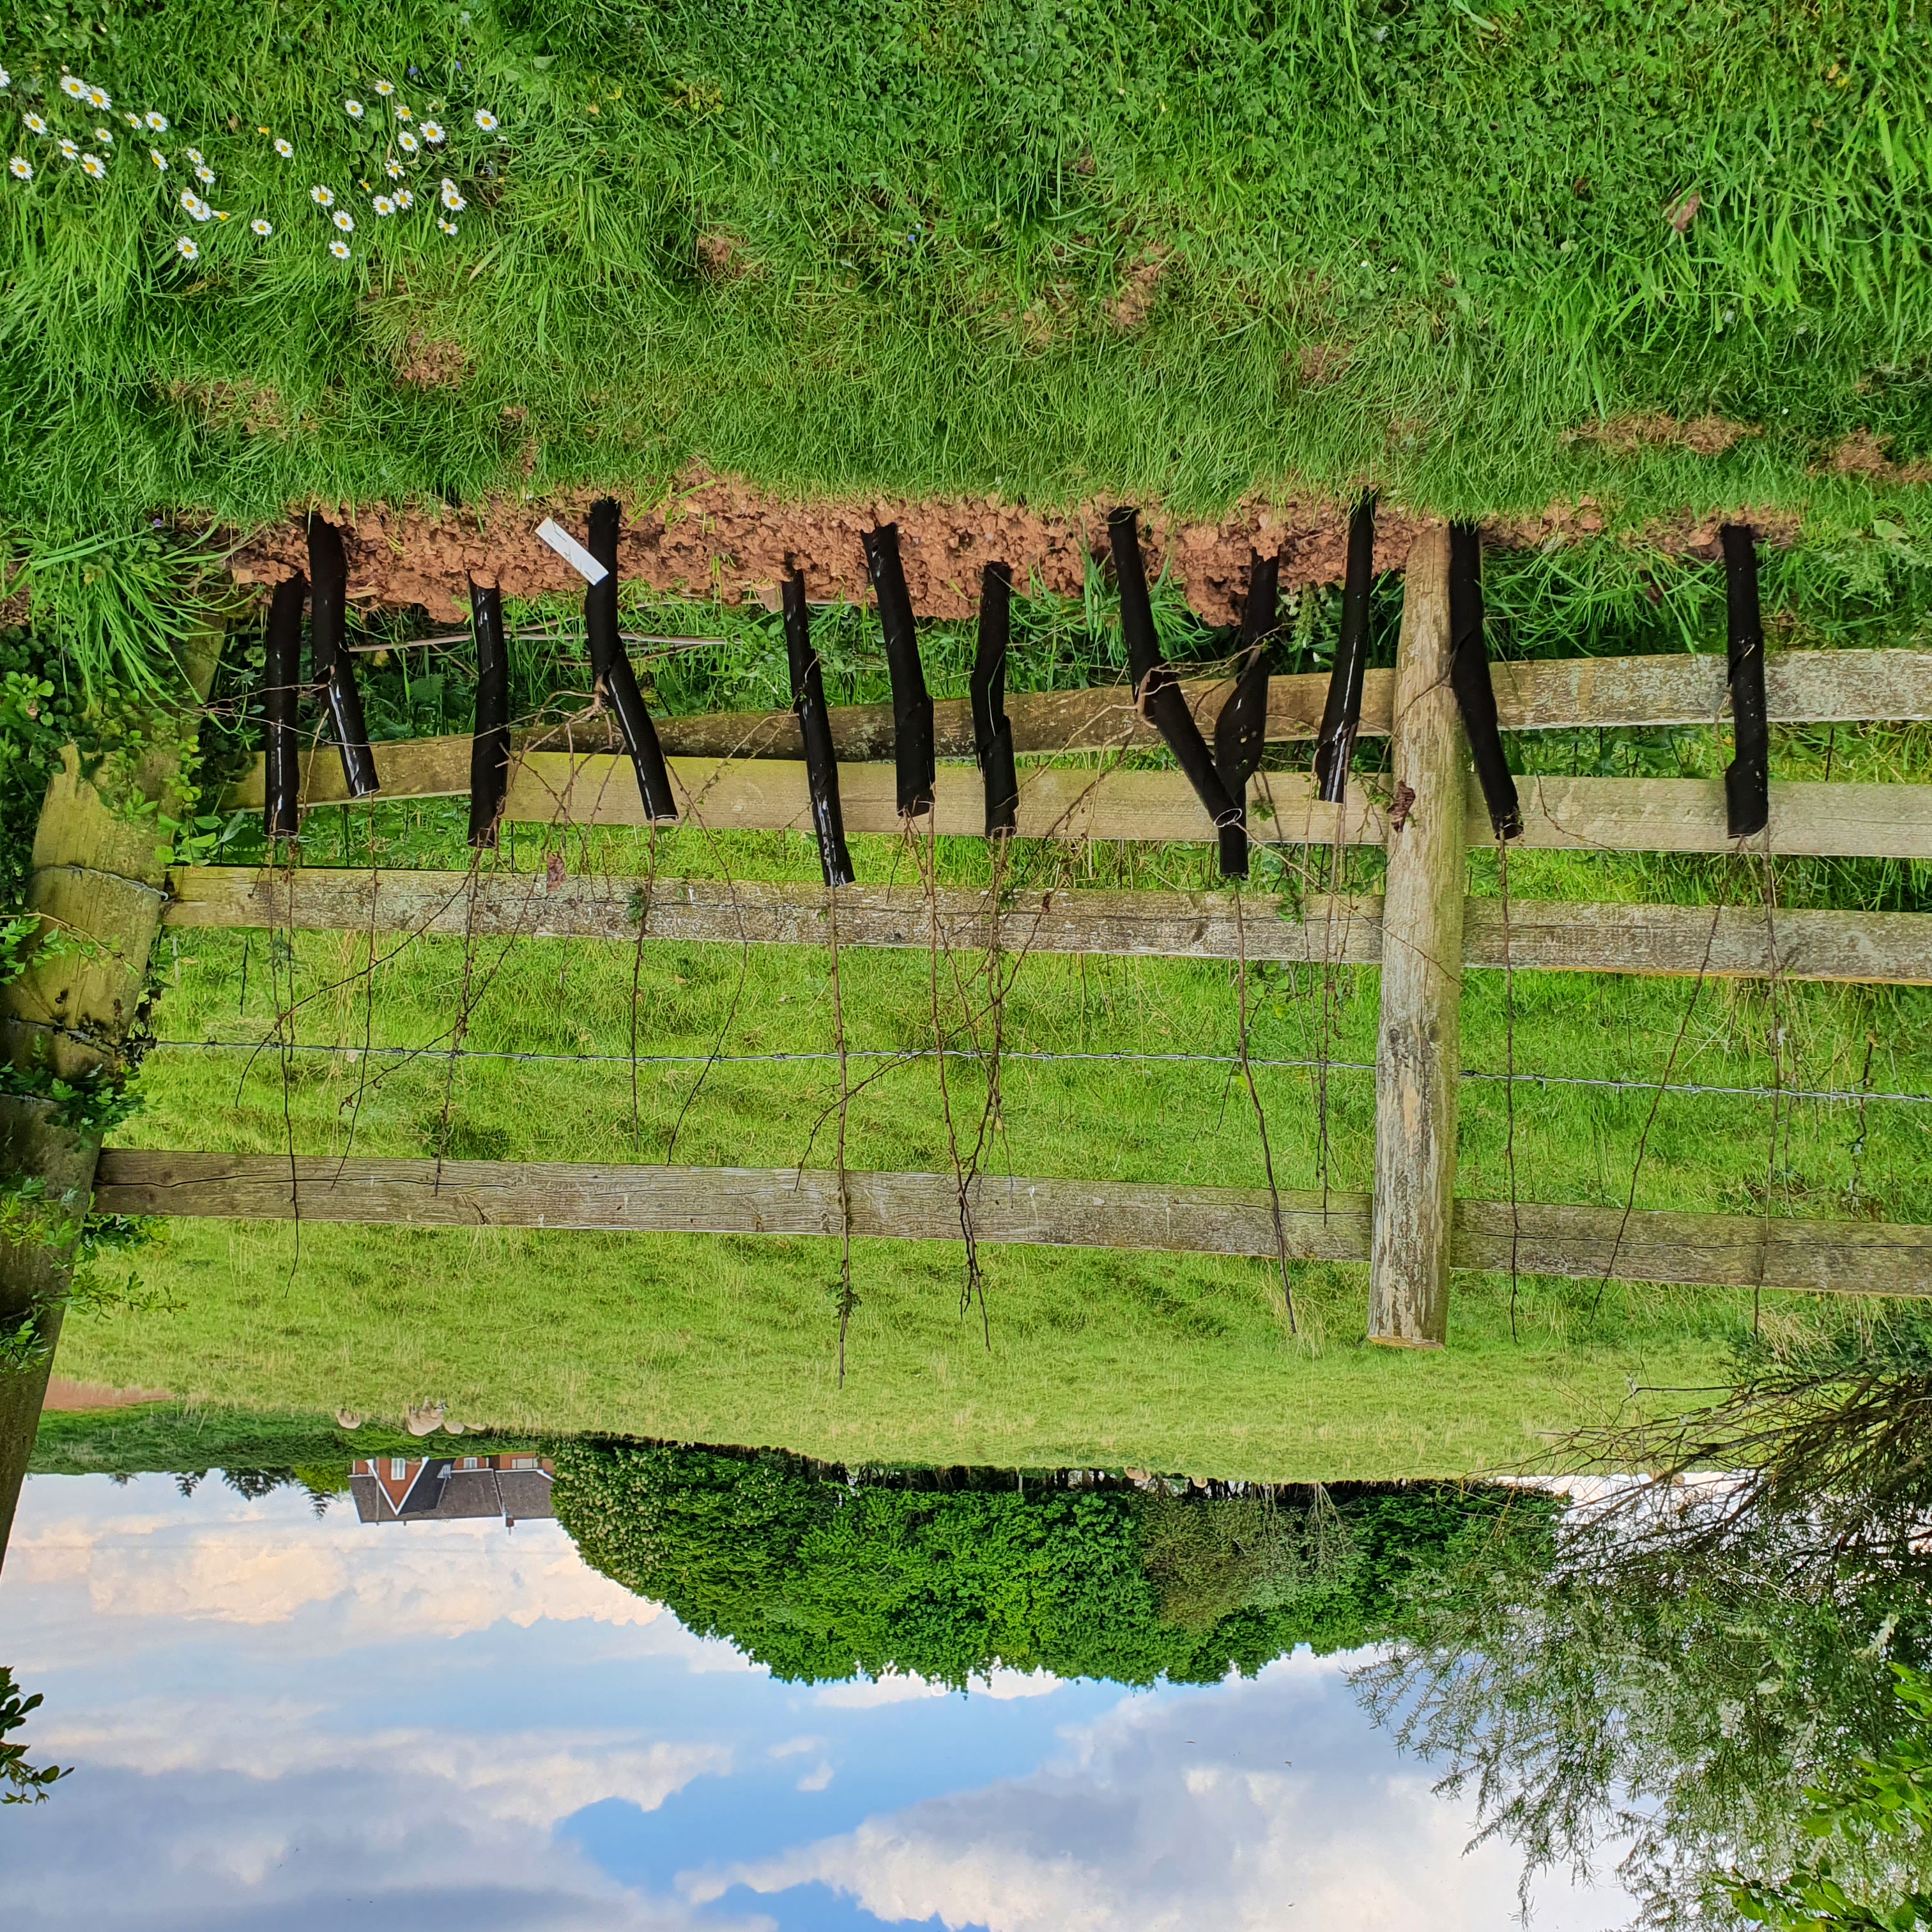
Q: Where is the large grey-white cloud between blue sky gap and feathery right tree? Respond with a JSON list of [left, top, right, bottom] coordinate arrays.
[[686, 1656, 1621, 1932]]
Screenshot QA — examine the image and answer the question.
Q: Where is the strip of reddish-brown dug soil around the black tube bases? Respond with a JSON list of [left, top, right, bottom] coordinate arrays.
[[232, 475, 1795, 624]]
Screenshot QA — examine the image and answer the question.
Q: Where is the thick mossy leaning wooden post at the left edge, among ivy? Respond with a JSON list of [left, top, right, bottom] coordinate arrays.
[[0, 628, 222, 1563]]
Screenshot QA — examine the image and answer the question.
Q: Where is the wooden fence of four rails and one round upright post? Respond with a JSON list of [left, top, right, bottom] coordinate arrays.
[[60, 548, 1932, 1347]]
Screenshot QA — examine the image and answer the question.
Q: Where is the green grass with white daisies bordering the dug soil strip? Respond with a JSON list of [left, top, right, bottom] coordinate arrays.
[[0, 0, 1932, 674]]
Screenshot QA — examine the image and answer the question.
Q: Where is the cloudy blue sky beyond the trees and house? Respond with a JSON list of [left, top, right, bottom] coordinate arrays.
[[0, 1476, 1630, 1932]]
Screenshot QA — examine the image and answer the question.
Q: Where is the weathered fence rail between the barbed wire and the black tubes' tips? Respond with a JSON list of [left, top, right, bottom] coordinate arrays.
[[166, 866, 1932, 985]]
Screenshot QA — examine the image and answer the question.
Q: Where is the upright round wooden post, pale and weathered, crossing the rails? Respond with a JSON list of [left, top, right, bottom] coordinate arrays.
[[1368, 526, 1466, 1349]]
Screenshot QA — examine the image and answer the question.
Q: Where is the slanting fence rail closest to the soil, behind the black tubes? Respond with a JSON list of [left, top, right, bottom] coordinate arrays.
[[230, 649, 1932, 809]]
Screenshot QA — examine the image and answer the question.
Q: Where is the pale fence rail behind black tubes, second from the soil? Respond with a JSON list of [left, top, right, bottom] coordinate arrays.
[[228, 740, 1932, 858]]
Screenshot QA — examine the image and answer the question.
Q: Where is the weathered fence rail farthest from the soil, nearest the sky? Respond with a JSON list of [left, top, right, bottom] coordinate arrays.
[[95, 1147, 1932, 1294]]
